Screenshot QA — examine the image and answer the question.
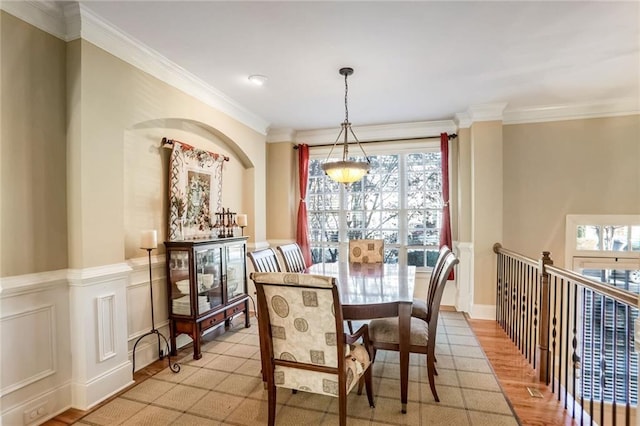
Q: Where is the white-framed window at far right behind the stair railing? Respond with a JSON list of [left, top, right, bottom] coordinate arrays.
[[566, 215, 640, 405]]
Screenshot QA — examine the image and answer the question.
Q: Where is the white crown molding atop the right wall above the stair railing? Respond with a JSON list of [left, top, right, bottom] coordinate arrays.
[[503, 98, 640, 124]]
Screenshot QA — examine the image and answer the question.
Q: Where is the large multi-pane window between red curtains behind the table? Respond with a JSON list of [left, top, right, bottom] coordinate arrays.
[[307, 143, 443, 266]]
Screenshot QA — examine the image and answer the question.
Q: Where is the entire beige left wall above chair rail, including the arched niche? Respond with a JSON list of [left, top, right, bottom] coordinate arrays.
[[0, 12, 266, 276]]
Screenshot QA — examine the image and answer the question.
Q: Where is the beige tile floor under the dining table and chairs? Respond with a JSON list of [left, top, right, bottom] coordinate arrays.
[[75, 311, 519, 426]]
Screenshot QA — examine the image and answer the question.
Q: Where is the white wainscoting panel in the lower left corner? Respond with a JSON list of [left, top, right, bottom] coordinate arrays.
[[0, 270, 71, 425]]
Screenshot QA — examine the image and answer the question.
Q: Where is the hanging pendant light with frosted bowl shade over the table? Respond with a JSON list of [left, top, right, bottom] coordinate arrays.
[[322, 68, 370, 185]]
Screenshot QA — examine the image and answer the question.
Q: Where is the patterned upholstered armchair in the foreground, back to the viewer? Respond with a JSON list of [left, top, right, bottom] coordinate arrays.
[[251, 272, 374, 426]]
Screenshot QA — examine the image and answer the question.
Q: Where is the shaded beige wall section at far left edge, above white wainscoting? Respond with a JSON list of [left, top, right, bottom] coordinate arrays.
[[0, 12, 67, 277]]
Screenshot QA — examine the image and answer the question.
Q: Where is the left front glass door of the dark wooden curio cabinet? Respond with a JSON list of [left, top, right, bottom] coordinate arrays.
[[195, 247, 223, 315]]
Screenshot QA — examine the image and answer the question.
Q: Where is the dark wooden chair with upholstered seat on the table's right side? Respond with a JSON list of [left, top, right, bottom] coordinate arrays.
[[369, 252, 459, 402]]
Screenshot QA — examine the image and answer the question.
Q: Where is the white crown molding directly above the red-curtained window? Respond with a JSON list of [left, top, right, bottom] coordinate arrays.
[[295, 120, 458, 145]]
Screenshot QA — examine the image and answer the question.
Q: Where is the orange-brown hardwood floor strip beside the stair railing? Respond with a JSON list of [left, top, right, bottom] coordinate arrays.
[[468, 319, 577, 425]]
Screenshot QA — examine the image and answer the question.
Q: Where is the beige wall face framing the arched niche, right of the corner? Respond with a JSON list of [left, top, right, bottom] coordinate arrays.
[[70, 40, 266, 268]]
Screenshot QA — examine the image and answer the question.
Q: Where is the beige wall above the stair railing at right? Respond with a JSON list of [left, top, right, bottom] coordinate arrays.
[[503, 115, 640, 267]]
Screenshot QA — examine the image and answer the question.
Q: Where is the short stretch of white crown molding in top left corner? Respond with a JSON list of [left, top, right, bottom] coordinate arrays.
[[0, 0, 68, 41]]
